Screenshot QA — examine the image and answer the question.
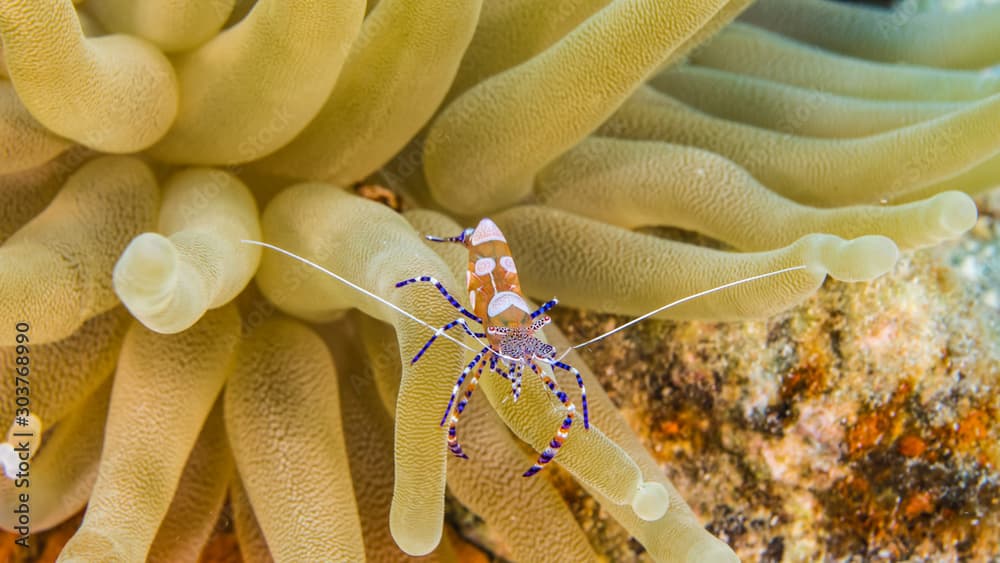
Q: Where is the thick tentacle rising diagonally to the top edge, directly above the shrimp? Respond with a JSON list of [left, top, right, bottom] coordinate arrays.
[[424, 0, 726, 215]]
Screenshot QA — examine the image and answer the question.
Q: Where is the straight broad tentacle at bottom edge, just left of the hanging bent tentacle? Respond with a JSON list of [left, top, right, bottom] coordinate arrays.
[[225, 316, 364, 561]]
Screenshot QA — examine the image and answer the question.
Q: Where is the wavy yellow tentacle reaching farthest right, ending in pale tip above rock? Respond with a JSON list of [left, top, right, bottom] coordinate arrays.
[[535, 137, 976, 250]]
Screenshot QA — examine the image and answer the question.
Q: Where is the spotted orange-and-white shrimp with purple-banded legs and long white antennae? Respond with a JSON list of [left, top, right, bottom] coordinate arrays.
[[241, 219, 806, 477]]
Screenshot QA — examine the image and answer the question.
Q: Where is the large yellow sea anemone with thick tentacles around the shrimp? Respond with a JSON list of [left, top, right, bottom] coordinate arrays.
[[0, 0, 1000, 561]]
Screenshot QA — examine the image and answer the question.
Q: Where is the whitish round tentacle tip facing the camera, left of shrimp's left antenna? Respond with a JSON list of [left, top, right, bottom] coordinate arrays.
[[112, 233, 179, 317]]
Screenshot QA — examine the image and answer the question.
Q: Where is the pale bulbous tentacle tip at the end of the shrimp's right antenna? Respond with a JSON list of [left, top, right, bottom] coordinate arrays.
[[805, 235, 899, 282]]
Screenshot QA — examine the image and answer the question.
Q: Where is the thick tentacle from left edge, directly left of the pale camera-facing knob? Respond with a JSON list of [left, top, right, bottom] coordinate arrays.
[[0, 157, 159, 345]]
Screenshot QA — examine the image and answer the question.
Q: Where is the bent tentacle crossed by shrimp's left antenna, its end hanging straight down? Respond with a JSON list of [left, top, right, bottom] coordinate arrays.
[[257, 183, 461, 555]]
